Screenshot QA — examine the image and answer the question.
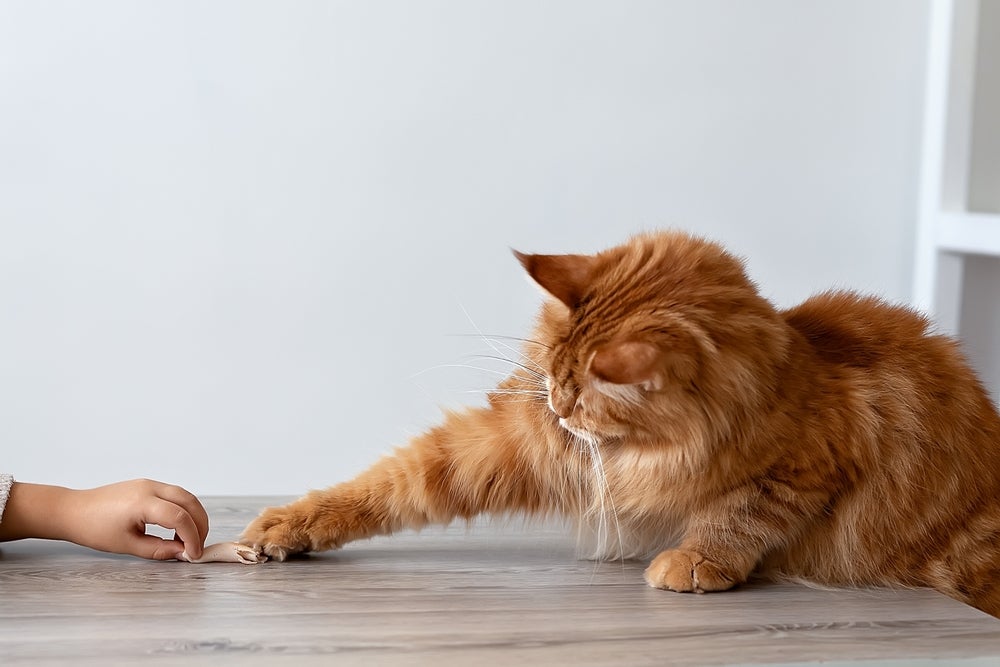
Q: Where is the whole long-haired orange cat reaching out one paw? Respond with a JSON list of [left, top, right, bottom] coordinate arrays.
[[243, 232, 1000, 615]]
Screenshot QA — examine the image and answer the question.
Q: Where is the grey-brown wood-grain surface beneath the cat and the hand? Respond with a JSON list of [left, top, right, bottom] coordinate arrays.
[[0, 498, 1000, 667]]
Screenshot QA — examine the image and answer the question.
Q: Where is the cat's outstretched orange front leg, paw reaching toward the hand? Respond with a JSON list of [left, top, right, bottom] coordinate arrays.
[[241, 408, 554, 561]]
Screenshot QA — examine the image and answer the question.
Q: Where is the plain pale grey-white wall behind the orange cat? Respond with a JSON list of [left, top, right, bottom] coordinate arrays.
[[0, 0, 927, 494]]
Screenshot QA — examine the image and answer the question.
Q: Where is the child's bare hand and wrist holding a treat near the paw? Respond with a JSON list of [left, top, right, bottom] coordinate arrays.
[[0, 479, 208, 560]]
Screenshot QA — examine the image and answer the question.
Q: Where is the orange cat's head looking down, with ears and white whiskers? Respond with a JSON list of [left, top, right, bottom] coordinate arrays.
[[515, 232, 787, 454]]
